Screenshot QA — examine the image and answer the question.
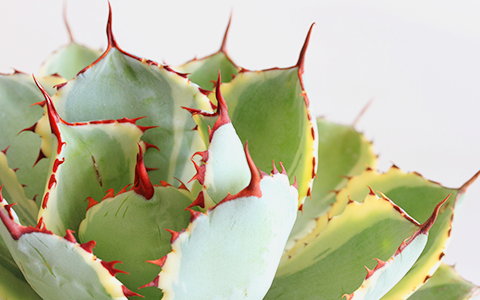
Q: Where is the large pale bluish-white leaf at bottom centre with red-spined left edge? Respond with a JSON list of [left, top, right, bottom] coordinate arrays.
[[156, 146, 298, 300]]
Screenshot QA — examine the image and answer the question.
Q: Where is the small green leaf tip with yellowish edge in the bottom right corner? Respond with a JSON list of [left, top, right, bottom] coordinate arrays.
[[408, 264, 480, 300]]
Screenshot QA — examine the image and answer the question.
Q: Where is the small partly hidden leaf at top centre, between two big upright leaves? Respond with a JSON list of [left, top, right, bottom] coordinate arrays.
[[175, 18, 240, 91]]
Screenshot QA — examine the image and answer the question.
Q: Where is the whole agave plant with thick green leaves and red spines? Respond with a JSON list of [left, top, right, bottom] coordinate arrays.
[[0, 2, 478, 299]]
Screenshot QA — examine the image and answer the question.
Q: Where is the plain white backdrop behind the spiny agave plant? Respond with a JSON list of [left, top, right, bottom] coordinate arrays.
[[0, 0, 480, 292]]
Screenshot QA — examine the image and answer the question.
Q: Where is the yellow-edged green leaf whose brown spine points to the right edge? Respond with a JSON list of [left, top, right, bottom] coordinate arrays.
[[329, 167, 475, 299]]
